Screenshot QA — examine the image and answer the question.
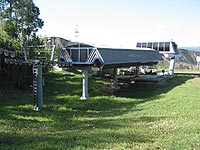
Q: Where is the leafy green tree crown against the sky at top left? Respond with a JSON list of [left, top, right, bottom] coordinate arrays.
[[0, 0, 44, 51]]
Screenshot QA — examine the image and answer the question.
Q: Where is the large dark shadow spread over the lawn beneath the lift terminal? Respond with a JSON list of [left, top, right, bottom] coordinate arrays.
[[0, 74, 195, 149]]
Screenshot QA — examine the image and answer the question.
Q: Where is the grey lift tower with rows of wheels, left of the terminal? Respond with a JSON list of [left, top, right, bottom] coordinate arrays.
[[0, 39, 72, 111]]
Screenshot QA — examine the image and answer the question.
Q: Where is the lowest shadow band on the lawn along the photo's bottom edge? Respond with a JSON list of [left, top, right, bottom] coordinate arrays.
[[0, 126, 153, 150]]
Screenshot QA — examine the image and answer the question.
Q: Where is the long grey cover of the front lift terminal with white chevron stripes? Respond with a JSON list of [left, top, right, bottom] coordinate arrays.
[[86, 48, 162, 68]]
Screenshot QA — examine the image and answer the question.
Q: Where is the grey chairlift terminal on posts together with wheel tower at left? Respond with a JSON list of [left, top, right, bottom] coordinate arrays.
[[0, 37, 162, 111]]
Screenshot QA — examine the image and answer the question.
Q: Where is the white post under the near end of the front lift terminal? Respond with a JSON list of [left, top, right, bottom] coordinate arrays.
[[80, 68, 89, 100]]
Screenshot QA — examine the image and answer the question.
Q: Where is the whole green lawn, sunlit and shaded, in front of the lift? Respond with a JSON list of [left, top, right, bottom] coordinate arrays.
[[0, 72, 200, 150]]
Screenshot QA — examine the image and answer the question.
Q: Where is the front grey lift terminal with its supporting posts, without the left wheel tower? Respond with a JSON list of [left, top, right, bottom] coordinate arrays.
[[62, 47, 162, 100]]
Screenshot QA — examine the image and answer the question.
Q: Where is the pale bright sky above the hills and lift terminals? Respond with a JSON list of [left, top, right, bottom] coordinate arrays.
[[34, 0, 200, 47]]
